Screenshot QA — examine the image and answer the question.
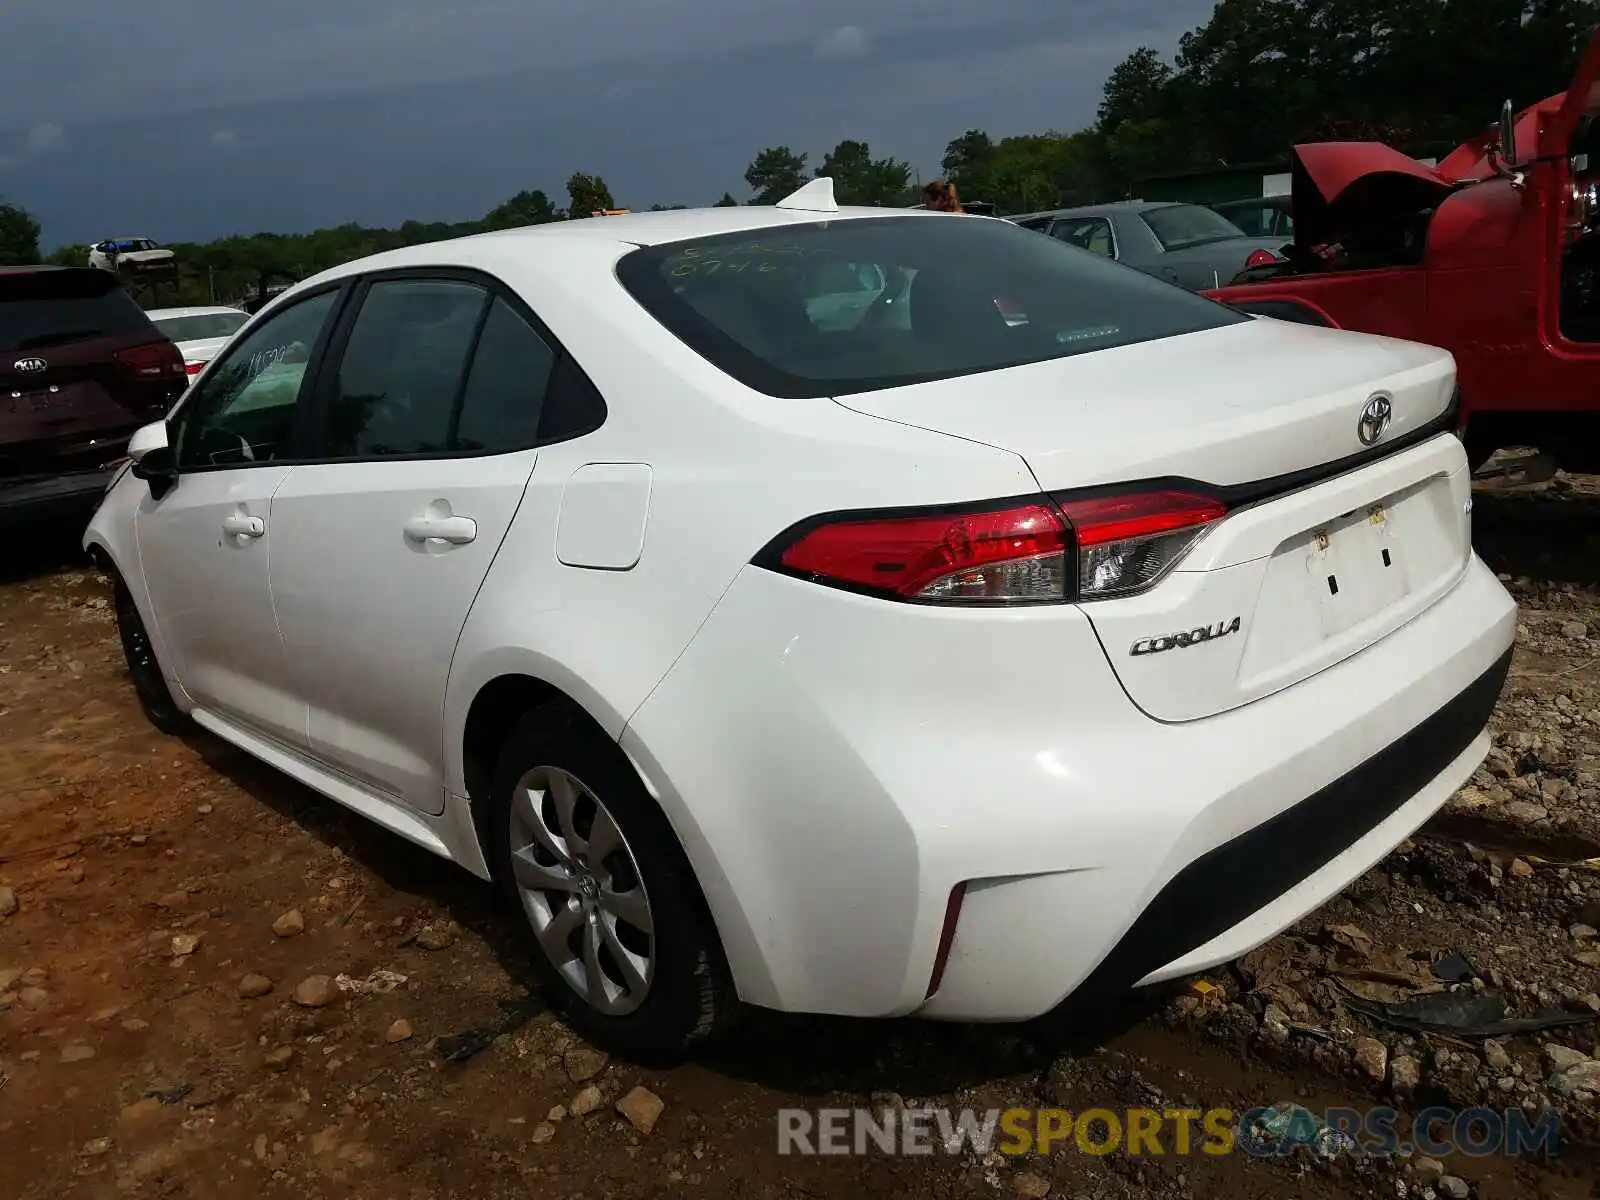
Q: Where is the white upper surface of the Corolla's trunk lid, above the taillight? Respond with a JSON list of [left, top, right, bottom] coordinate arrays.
[[837, 320, 1454, 490]]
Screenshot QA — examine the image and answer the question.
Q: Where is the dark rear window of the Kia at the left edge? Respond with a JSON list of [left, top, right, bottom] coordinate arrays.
[[0, 267, 154, 352]]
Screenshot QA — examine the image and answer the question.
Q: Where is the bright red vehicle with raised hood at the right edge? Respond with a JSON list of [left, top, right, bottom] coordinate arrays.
[[1206, 25, 1600, 472]]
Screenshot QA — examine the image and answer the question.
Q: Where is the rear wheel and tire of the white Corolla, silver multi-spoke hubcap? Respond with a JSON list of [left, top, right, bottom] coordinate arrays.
[[490, 706, 736, 1059]]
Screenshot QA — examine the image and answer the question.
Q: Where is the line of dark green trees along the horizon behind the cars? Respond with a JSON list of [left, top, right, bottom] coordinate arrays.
[[0, 0, 1600, 302]]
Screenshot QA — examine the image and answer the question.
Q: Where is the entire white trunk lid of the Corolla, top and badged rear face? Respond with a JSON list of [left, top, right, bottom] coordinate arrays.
[[838, 320, 1472, 722]]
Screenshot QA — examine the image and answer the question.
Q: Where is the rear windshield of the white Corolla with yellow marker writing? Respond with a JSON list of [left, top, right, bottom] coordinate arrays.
[[618, 216, 1248, 398]]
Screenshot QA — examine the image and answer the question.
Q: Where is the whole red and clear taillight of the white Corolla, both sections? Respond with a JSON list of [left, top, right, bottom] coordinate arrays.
[[755, 491, 1227, 605]]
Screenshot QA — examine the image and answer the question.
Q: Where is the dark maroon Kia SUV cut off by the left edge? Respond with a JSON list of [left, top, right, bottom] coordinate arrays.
[[0, 267, 187, 525]]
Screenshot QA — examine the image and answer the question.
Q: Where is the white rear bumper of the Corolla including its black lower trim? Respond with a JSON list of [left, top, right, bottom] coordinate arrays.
[[622, 557, 1517, 1021]]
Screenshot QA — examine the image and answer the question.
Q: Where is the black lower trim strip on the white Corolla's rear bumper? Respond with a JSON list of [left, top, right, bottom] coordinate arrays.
[[1074, 650, 1512, 998]]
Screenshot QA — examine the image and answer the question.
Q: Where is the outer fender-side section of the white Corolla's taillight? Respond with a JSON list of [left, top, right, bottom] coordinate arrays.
[[778, 502, 1070, 603]]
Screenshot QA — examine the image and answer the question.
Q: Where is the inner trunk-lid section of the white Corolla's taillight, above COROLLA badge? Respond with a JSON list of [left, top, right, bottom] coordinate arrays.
[[1061, 491, 1227, 600]]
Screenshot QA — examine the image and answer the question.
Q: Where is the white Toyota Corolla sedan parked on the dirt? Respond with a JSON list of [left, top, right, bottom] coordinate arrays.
[[86, 181, 1515, 1051]]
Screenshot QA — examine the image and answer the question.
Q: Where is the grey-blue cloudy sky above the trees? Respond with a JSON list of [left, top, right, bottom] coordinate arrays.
[[0, 0, 1211, 248]]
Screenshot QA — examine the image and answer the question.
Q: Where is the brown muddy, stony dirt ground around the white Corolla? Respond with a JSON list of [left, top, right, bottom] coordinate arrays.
[[0, 477, 1600, 1200]]
